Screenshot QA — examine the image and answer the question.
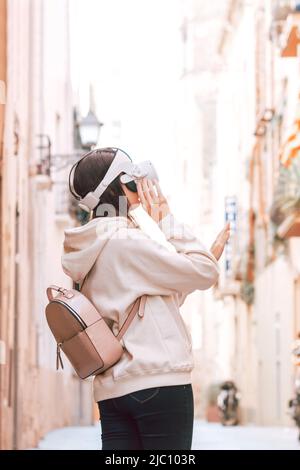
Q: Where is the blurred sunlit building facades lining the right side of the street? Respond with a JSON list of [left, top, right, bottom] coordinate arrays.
[[177, 0, 300, 425]]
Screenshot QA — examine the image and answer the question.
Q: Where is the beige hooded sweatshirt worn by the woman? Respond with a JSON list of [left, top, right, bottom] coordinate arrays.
[[62, 214, 219, 401]]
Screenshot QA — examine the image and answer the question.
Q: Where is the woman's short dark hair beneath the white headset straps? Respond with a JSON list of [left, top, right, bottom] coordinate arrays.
[[73, 148, 129, 219]]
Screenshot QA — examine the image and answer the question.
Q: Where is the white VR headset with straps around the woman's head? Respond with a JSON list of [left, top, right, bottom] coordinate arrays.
[[69, 147, 158, 212]]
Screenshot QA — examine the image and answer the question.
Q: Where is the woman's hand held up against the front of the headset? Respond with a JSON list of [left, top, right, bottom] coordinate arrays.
[[136, 177, 171, 223]]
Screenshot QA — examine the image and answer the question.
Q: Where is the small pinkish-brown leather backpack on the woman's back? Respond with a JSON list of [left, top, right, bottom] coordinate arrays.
[[45, 285, 145, 379]]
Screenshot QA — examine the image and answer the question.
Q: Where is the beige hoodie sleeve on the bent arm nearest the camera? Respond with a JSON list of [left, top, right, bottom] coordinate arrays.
[[114, 214, 219, 303]]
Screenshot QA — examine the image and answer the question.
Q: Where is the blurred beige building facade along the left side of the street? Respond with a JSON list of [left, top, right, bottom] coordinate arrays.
[[0, 0, 93, 449]]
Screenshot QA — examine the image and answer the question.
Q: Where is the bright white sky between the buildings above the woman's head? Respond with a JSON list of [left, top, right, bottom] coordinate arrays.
[[70, 0, 182, 185]]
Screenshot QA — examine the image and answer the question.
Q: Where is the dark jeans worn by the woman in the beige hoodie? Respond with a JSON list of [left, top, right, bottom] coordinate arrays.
[[98, 384, 194, 450]]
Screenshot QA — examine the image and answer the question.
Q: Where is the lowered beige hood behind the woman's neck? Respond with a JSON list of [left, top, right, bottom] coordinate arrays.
[[61, 216, 136, 282]]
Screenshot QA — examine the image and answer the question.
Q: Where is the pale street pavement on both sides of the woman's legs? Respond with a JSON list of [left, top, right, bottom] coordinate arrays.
[[37, 421, 300, 450]]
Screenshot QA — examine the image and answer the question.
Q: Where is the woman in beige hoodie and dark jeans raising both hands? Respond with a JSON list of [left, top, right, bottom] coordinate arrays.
[[62, 148, 229, 450]]
